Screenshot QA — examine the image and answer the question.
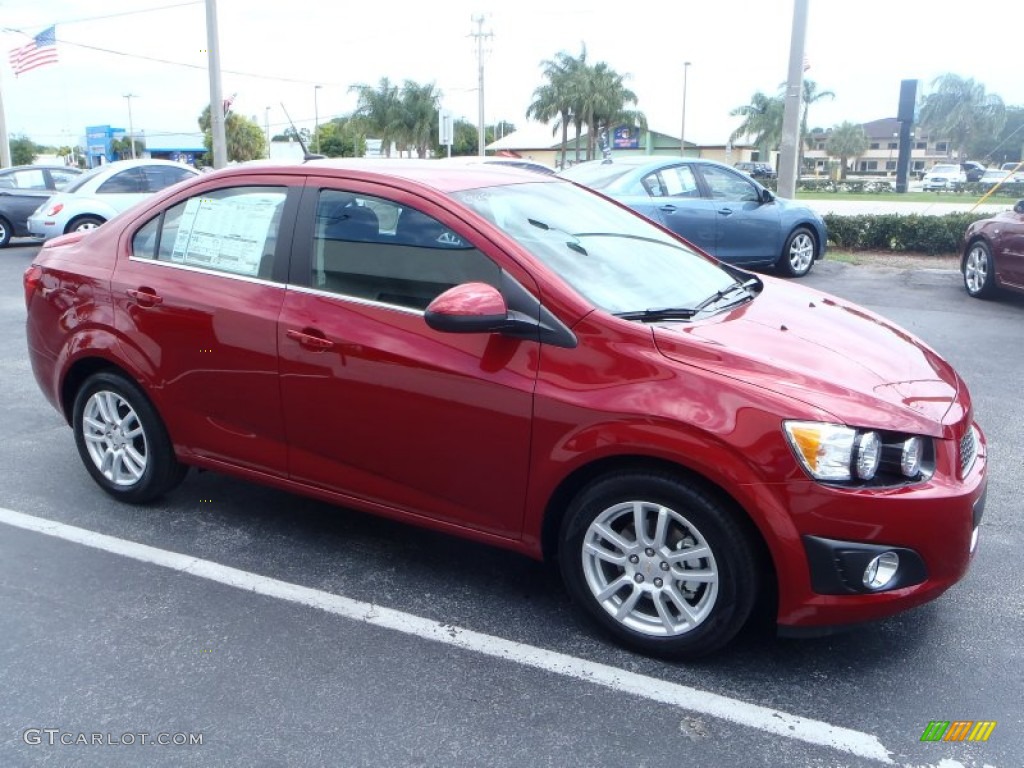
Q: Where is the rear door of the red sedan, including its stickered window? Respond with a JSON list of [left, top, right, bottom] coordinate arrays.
[[112, 176, 301, 477]]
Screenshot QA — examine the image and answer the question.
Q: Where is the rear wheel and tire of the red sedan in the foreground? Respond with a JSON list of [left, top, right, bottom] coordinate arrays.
[[73, 372, 188, 504]]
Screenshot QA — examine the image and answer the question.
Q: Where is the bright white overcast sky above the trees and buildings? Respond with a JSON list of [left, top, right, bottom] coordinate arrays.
[[0, 0, 1024, 151]]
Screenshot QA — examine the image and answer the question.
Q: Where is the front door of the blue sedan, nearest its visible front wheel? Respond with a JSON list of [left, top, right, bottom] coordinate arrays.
[[695, 163, 782, 264]]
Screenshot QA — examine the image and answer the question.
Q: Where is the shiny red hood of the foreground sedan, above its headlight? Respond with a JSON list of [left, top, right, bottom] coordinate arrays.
[[654, 278, 968, 436]]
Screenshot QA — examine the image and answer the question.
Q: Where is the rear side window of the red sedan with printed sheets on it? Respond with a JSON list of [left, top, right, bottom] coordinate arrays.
[[132, 186, 287, 280]]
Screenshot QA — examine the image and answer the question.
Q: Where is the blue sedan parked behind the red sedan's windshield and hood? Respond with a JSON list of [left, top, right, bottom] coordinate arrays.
[[559, 155, 828, 278]]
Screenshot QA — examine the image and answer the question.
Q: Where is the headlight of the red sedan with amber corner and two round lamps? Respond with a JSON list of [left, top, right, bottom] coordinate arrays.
[[782, 421, 935, 485]]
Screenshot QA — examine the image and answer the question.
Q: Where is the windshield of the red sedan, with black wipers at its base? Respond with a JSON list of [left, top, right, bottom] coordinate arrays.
[[453, 182, 737, 313]]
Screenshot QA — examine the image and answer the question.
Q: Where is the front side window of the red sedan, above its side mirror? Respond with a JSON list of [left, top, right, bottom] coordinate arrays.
[[310, 189, 501, 309]]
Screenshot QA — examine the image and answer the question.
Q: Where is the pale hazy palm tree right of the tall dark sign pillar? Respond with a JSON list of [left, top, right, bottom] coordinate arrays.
[[918, 74, 1007, 160]]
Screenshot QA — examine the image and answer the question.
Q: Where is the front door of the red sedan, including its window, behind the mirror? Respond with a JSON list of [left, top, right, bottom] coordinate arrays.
[[279, 178, 539, 538]]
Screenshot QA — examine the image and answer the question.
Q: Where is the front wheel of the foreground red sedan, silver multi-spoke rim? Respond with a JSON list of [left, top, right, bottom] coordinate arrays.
[[559, 472, 759, 659]]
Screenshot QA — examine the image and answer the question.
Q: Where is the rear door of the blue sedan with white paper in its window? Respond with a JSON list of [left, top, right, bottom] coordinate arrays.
[[628, 163, 716, 254]]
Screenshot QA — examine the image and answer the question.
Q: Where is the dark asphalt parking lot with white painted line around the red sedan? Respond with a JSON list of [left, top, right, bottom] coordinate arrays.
[[0, 245, 1024, 768]]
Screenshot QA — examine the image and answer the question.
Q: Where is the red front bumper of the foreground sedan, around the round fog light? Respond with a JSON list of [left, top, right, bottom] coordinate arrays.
[[778, 430, 987, 635]]
